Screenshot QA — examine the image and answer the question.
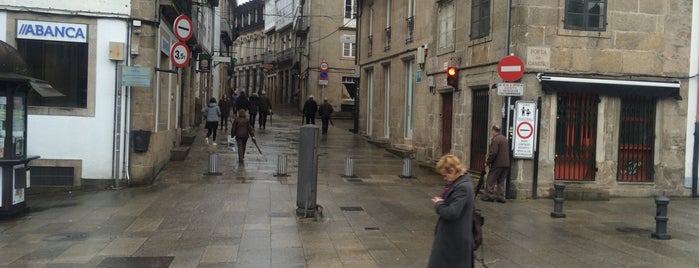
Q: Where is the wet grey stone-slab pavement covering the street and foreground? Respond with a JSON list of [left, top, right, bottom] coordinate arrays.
[[0, 105, 699, 267]]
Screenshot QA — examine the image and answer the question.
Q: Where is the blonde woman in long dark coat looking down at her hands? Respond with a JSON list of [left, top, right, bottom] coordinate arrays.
[[427, 154, 474, 268]]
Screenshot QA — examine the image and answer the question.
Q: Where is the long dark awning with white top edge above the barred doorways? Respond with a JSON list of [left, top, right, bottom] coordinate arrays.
[[538, 75, 682, 100]]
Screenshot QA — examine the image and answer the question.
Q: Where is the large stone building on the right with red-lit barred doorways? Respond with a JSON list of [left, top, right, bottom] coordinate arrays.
[[358, 0, 696, 198]]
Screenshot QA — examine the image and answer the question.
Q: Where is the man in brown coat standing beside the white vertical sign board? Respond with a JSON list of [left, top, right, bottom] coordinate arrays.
[[481, 125, 510, 203]]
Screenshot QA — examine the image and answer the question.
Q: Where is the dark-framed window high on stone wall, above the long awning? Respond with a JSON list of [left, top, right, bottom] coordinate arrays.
[[565, 0, 607, 31]]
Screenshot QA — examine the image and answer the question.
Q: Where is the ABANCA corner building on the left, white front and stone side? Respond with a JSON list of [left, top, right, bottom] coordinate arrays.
[[0, 0, 235, 188]]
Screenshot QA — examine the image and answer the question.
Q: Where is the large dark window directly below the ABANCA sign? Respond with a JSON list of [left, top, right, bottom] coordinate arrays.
[[17, 39, 88, 108]]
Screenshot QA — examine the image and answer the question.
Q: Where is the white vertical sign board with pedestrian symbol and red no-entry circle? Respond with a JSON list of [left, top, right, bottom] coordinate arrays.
[[513, 101, 539, 159]]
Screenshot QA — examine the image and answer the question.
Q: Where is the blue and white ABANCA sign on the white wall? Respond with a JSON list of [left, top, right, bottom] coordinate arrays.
[[17, 20, 87, 43]]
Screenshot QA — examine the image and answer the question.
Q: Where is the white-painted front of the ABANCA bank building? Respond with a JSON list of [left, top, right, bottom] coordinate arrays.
[[0, 0, 131, 184]]
